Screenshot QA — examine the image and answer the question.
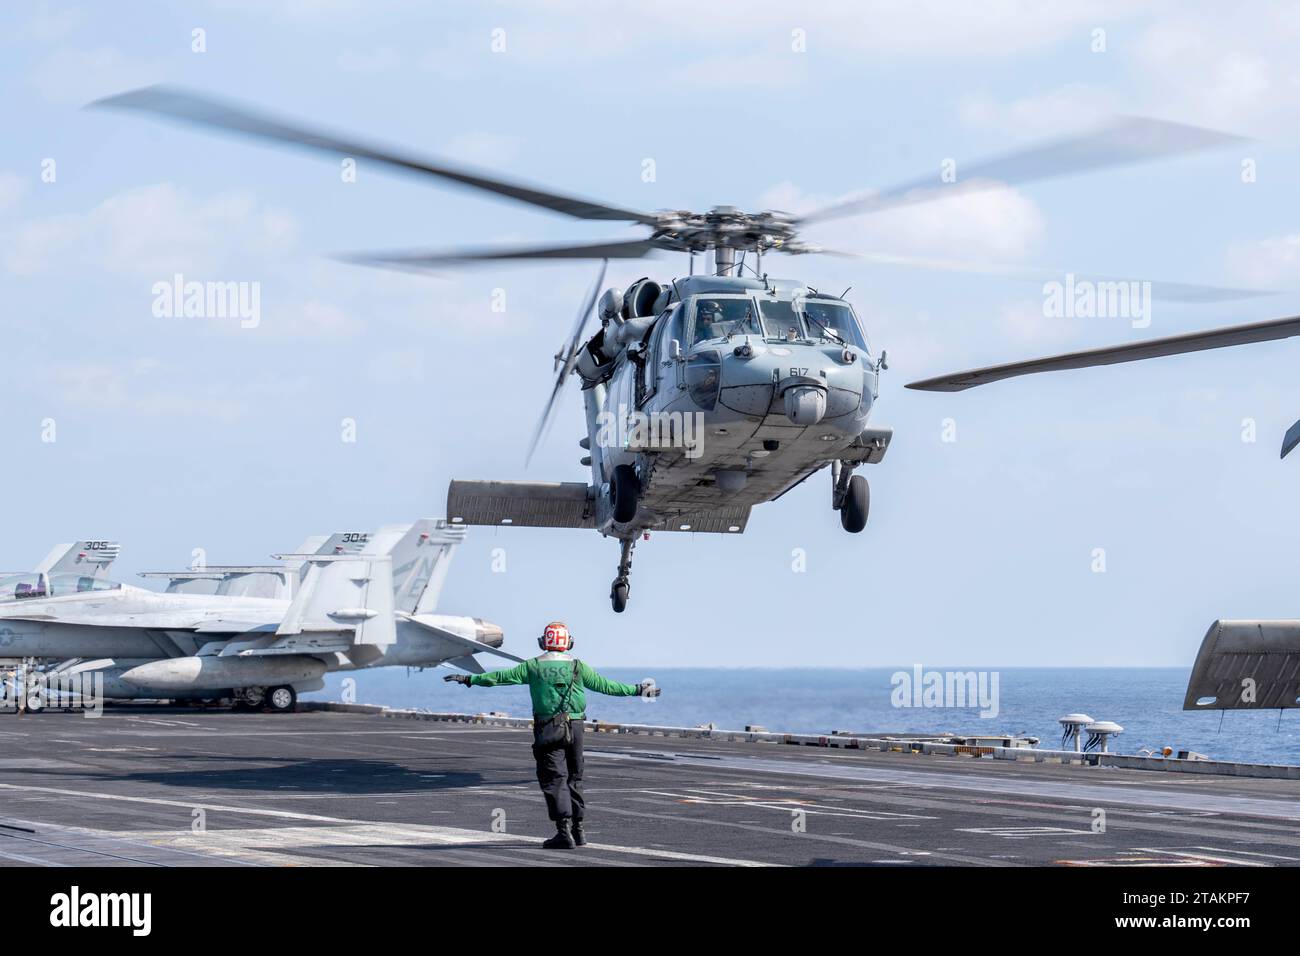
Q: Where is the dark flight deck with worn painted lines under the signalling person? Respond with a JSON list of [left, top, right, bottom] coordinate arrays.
[[0, 706, 1300, 868]]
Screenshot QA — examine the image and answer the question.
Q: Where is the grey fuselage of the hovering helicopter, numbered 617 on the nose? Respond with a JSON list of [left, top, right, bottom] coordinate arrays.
[[577, 276, 879, 537]]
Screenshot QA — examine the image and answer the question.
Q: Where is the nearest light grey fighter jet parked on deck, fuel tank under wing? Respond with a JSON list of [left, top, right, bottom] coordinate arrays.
[[0, 519, 519, 710]]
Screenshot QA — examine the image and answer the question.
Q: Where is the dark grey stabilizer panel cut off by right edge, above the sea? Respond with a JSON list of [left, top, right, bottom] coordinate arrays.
[[1183, 620, 1300, 710]]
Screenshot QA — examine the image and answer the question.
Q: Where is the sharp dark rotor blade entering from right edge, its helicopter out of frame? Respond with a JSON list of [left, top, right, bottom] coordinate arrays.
[[907, 310, 1300, 392]]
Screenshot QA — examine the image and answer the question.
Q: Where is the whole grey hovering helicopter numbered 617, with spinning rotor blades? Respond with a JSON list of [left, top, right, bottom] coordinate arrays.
[[91, 87, 1257, 613]]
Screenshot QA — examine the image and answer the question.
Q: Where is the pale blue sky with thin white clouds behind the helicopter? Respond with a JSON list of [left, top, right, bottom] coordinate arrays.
[[0, 0, 1300, 667]]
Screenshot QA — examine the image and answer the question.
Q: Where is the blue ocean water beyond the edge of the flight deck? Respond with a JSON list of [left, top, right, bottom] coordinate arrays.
[[303, 666, 1300, 765]]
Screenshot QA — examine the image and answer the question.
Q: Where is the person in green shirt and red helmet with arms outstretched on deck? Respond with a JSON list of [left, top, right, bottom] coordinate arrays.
[[443, 620, 659, 849]]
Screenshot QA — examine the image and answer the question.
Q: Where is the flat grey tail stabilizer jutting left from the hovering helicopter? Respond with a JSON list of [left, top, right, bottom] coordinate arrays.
[[447, 480, 595, 528]]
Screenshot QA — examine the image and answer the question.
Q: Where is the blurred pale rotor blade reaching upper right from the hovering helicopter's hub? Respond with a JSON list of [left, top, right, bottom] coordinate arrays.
[[798, 116, 1245, 224]]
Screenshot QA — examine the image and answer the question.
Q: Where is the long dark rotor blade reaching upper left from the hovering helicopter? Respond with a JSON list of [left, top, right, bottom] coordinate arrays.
[[90, 86, 655, 225]]
